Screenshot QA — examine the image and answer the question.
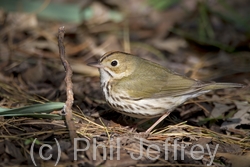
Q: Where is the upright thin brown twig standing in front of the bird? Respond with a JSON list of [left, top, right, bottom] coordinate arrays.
[[58, 26, 77, 144]]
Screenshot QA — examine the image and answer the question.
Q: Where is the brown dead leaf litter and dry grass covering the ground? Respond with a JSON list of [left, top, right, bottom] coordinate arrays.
[[0, 1, 250, 167]]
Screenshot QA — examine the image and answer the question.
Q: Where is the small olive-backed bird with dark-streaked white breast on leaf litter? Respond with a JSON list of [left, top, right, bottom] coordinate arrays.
[[88, 51, 243, 133]]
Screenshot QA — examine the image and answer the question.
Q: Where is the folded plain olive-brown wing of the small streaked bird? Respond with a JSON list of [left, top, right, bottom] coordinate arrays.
[[113, 61, 202, 99]]
